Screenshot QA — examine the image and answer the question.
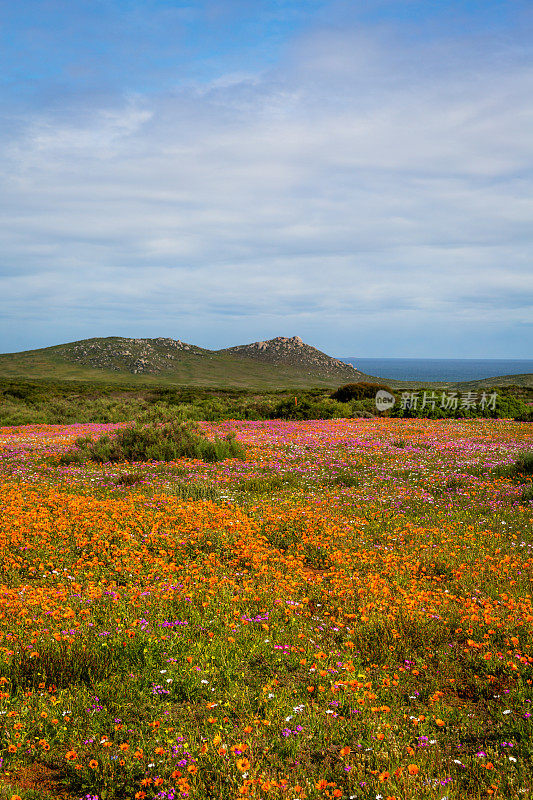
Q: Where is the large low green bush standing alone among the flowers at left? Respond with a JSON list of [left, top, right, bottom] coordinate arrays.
[[60, 422, 245, 464]]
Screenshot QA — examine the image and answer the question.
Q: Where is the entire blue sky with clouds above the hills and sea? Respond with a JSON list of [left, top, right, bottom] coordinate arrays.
[[0, 0, 533, 358]]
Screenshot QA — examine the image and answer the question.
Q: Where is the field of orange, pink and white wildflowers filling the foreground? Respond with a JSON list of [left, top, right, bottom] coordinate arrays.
[[0, 418, 533, 800]]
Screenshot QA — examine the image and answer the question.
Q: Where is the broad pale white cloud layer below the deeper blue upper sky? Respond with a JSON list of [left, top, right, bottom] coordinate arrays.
[[0, 27, 533, 355]]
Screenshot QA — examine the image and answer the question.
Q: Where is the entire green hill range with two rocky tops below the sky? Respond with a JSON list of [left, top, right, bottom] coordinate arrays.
[[0, 336, 365, 388]]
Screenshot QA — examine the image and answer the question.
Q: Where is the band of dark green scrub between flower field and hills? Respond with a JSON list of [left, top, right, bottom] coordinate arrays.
[[0, 380, 533, 426]]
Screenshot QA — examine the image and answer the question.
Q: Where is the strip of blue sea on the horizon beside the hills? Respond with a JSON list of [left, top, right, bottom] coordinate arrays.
[[341, 358, 533, 381]]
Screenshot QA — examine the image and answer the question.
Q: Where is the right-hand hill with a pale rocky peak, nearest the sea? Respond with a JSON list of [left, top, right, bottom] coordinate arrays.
[[218, 336, 360, 380]]
